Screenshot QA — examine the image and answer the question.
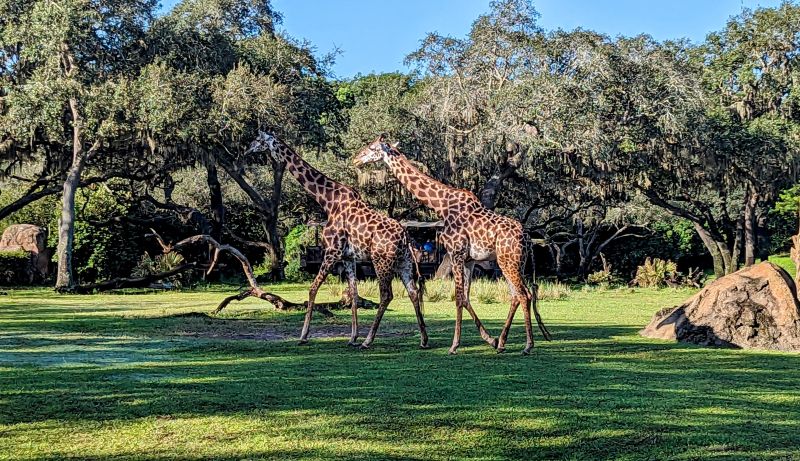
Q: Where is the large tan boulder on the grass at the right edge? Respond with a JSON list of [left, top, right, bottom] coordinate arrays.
[[640, 262, 800, 351]]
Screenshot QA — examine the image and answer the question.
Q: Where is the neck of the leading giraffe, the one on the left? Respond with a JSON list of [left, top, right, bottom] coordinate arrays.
[[278, 143, 355, 216]]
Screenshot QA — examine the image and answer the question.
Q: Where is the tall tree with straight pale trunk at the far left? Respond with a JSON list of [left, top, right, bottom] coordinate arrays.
[[0, 0, 156, 289]]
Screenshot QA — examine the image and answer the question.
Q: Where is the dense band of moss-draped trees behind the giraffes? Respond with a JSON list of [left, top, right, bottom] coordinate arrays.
[[0, 0, 800, 288]]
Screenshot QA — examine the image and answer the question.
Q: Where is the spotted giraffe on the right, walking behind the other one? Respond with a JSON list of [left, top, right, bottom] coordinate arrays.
[[353, 135, 551, 355]]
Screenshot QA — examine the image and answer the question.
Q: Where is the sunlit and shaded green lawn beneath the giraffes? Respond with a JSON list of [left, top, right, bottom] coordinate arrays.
[[0, 285, 800, 460]]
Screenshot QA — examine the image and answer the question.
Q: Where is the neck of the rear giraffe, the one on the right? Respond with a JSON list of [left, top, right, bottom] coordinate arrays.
[[386, 150, 463, 218]]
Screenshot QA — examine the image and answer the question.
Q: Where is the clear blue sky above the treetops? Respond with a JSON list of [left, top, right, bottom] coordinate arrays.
[[162, 0, 780, 77]]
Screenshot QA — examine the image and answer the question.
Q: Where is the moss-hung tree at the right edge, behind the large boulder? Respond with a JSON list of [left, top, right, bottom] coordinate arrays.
[[703, 2, 800, 266]]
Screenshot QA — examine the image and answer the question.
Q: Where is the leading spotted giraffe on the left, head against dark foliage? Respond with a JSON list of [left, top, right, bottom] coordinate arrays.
[[246, 131, 429, 349]]
